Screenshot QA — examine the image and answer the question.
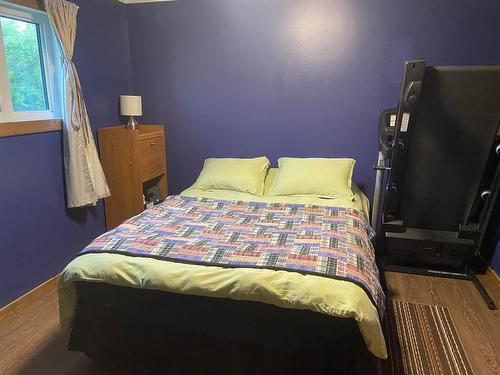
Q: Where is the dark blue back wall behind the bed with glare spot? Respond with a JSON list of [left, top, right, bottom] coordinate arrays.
[[127, 0, 500, 271]]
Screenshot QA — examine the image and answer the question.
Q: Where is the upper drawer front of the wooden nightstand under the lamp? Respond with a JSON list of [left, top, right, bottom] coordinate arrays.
[[139, 137, 166, 182]]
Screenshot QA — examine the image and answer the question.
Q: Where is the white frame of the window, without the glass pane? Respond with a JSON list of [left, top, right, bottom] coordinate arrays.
[[0, 1, 62, 122]]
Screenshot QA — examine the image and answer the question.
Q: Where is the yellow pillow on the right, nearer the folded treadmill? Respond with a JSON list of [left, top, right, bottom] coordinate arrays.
[[269, 158, 356, 198]]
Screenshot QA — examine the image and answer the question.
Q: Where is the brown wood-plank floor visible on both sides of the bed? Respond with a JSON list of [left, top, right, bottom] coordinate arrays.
[[0, 273, 500, 375]]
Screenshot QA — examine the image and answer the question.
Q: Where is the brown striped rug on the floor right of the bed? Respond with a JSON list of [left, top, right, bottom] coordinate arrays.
[[379, 300, 473, 375]]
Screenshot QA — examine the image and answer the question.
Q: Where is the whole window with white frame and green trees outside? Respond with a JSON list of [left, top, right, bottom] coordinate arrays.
[[0, 1, 61, 126]]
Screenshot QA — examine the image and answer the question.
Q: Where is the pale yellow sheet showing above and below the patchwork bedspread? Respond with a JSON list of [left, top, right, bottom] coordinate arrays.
[[59, 172, 387, 358]]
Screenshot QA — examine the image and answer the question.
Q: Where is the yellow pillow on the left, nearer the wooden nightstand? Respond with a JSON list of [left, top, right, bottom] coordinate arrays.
[[192, 156, 269, 195]]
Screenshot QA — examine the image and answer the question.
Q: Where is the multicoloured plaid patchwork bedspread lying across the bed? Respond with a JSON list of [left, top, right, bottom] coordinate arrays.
[[80, 196, 385, 314]]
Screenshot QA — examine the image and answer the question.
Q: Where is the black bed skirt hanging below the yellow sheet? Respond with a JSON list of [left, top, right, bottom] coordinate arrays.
[[68, 282, 377, 375]]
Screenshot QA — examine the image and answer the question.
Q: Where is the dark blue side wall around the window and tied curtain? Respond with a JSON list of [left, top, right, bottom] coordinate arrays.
[[0, 0, 132, 306]]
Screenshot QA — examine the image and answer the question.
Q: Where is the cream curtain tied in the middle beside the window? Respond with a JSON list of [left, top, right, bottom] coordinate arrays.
[[44, 0, 110, 207]]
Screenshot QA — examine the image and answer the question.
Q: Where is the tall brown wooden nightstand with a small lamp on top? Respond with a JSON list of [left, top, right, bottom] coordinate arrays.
[[97, 125, 167, 230]]
